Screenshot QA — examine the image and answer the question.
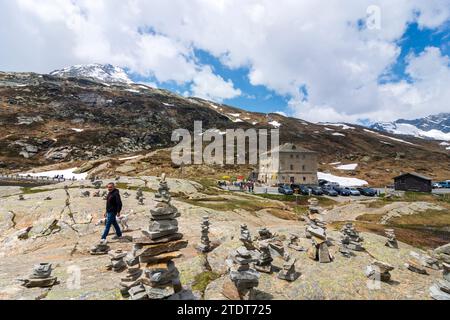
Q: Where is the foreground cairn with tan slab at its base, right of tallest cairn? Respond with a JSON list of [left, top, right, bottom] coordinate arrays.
[[222, 246, 259, 300]]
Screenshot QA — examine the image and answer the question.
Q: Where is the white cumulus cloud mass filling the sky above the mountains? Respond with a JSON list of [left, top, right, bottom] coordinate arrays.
[[0, 0, 450, 122]]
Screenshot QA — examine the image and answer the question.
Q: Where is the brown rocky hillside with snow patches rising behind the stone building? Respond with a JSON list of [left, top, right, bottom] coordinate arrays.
[[0, 73, 450, 184]]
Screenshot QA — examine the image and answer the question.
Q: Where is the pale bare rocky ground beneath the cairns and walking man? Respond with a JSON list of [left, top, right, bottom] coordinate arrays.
[[0, 177, 445, 300]]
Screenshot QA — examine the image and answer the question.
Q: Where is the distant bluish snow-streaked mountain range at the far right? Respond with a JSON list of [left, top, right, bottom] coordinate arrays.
[[371, 113, 450, 141]]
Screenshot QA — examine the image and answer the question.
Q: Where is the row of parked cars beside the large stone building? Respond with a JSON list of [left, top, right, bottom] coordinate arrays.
[[278, 183, 377, 197]]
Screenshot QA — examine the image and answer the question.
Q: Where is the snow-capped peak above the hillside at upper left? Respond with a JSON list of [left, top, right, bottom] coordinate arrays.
[[50, 63, 133, 84]]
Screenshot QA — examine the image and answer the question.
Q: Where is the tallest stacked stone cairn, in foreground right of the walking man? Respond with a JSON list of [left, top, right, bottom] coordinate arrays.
[[121, 174, 189, 300]]
